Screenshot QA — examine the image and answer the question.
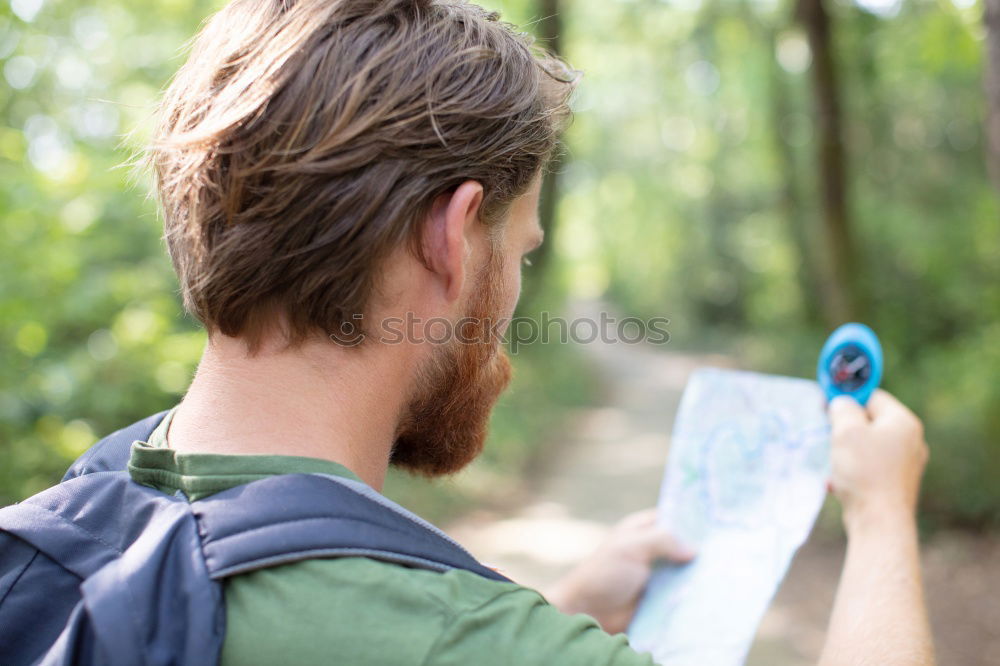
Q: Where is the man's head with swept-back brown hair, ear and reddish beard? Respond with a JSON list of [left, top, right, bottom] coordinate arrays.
[[151, 0, 572, 474]]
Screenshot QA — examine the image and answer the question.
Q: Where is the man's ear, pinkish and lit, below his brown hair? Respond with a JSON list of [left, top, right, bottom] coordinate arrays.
[[423, 180, 483, 302]]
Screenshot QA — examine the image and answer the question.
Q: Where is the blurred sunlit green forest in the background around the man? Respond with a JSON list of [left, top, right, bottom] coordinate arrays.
[[0, 0, 1000, 531]]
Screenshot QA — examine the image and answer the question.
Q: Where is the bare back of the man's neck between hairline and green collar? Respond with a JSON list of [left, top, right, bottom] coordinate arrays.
[[169, 335, 410, 490]]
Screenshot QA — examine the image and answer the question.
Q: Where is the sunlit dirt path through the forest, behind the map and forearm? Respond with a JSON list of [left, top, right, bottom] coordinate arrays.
[[447, 312, 1000, 666]]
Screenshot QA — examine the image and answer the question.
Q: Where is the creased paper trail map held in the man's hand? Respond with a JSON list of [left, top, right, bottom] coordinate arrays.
[[628, 368, 829, 666]]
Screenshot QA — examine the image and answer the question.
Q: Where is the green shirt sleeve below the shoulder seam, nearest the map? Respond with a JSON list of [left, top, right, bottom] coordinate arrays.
[[424, 588, 654, 666]]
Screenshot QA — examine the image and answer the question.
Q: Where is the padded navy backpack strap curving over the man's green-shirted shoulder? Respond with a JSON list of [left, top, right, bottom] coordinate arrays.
[[191, 474, 508, 581]]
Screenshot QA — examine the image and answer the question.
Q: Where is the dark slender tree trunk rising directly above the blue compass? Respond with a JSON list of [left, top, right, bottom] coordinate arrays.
[[797, 0, 858, 321]]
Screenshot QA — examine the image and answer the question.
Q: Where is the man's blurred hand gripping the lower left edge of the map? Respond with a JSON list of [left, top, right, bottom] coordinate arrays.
[[545, 509, 694, 634]]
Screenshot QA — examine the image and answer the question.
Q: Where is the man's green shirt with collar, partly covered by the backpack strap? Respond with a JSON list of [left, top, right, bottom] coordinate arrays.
[[128, 411, 653, 666]]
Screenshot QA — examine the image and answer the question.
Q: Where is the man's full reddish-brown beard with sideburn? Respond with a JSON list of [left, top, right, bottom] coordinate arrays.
[[389, 250, 511, 477]]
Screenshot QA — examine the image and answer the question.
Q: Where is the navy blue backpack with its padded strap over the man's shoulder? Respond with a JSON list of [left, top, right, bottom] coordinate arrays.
[[0, 412, 508, 666]]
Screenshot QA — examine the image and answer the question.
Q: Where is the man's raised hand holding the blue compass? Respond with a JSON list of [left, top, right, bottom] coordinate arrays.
[[830, 390, 928, 526]]
